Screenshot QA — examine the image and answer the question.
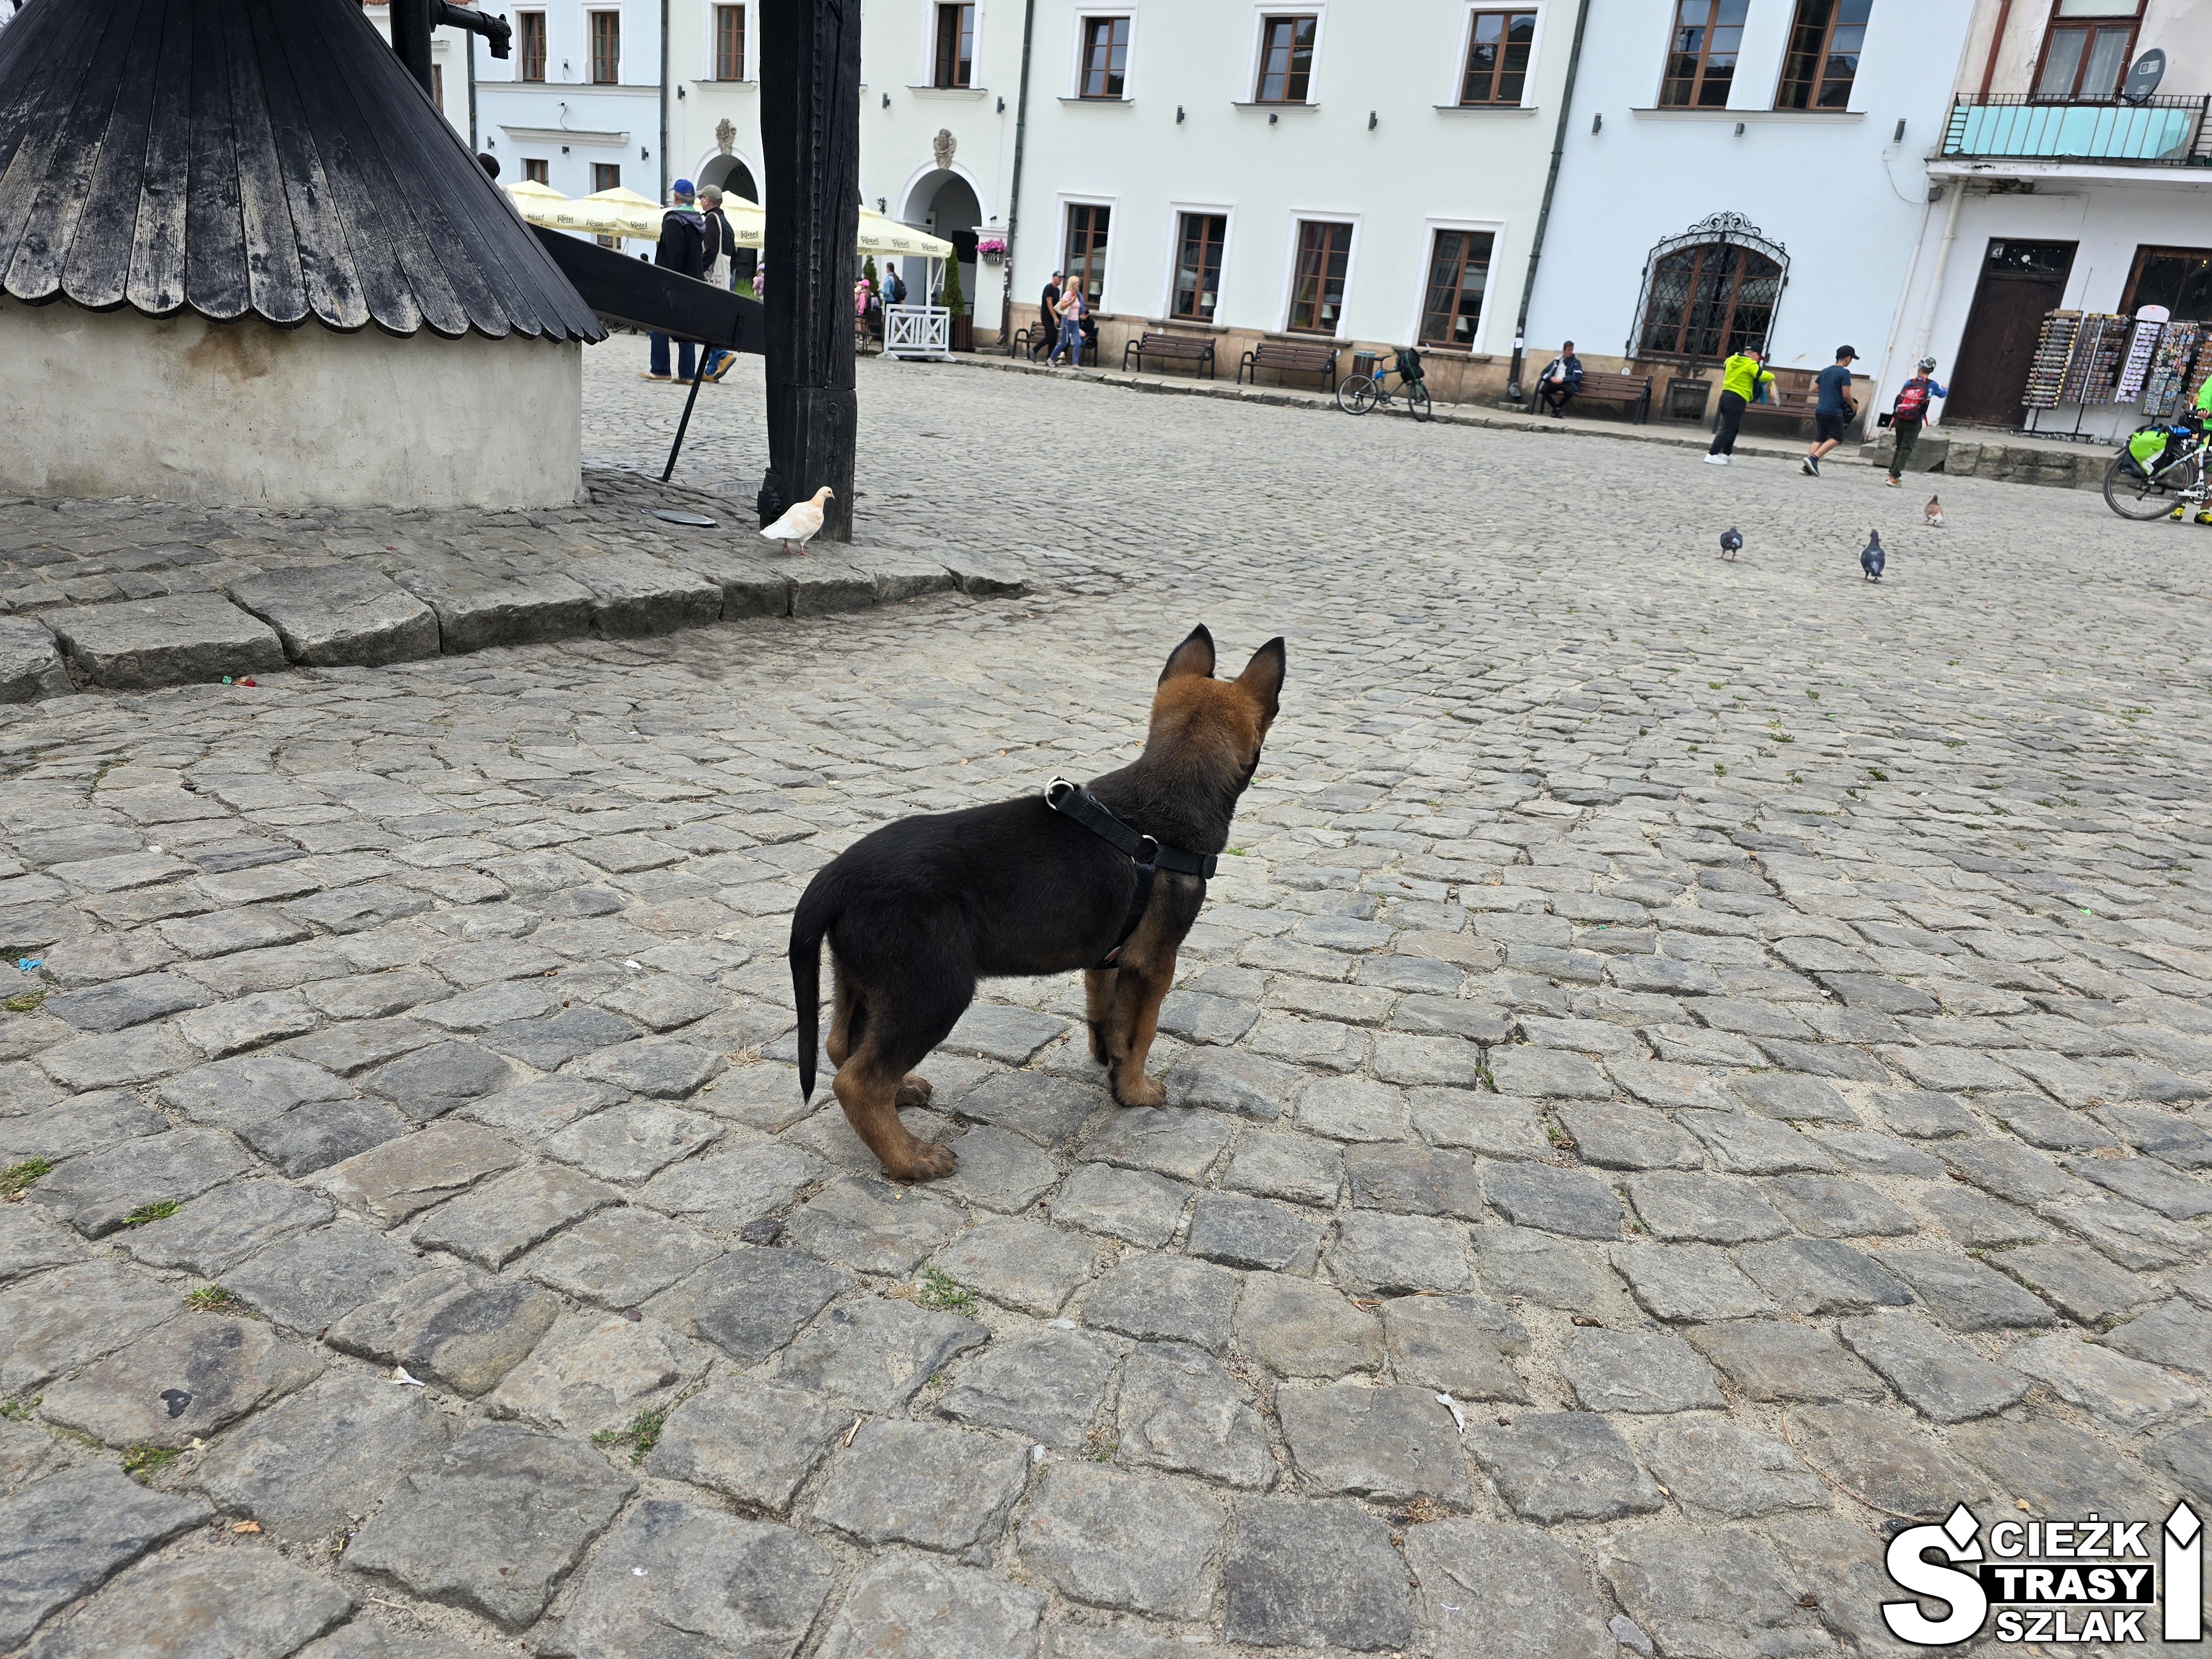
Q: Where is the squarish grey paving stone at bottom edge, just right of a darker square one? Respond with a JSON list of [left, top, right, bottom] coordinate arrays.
[[1405, 1517, 1619, 1659]]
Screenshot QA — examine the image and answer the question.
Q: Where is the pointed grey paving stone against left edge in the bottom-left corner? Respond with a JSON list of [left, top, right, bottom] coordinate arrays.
[[0, 1462, 208, 1650]]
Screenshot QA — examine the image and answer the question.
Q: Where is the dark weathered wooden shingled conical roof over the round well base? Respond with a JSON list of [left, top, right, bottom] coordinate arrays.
[[0, 0, 606, 341]]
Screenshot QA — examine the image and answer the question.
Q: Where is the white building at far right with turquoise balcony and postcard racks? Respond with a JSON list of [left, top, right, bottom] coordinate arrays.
[[1887, 0, 2212, 438]]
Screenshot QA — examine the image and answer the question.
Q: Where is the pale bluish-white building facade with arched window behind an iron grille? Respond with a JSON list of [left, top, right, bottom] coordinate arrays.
[[1528, 0, 1982, 425]]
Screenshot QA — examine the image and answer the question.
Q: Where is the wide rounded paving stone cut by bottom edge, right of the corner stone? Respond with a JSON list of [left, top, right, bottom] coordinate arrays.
[[33, 1551, 356, 1659]]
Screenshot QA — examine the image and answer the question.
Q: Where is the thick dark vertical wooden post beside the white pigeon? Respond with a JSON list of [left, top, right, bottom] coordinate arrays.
[[759, 0, 860, 542]]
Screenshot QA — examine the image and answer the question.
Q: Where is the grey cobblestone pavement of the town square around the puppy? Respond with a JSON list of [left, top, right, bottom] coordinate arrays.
[[0, 341, 2212, 1659]]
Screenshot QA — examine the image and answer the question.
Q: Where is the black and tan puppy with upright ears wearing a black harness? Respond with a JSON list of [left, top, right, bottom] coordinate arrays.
[[792, 628, 1283, 1181]]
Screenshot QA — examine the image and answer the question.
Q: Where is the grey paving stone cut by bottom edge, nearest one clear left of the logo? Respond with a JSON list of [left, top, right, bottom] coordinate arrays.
[[1597, 1526, 1834, 1659]]
